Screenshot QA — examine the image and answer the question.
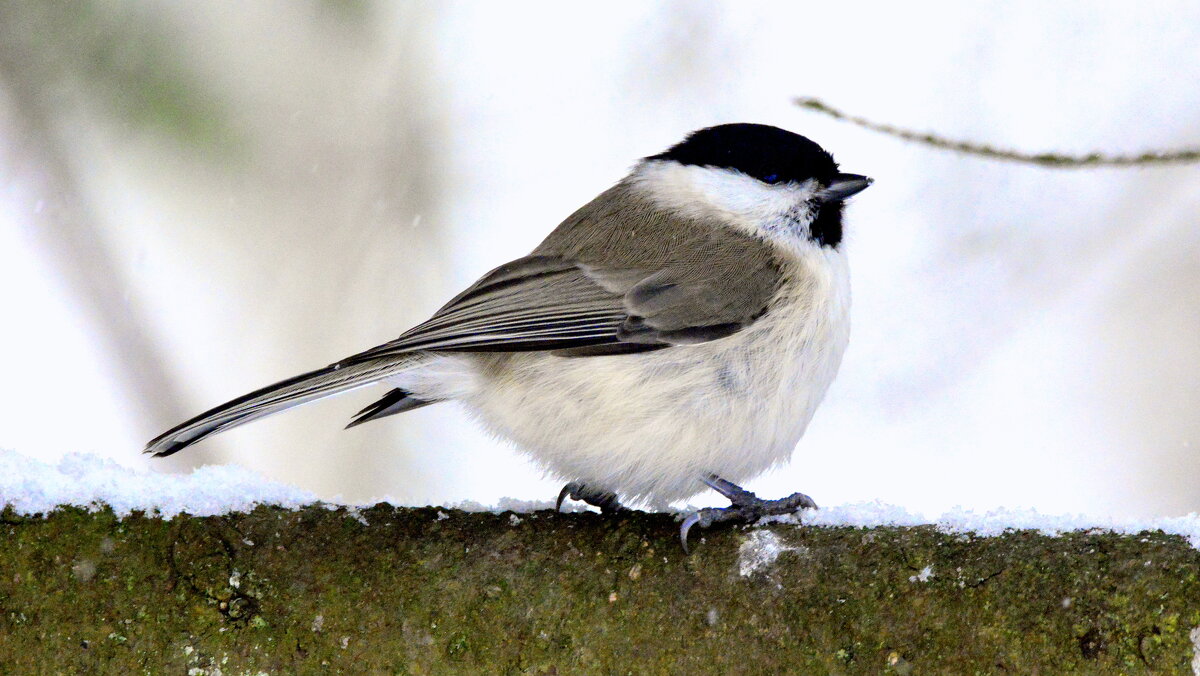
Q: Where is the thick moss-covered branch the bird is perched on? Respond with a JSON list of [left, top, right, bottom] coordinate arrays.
[[0, 505, 1200, 674]]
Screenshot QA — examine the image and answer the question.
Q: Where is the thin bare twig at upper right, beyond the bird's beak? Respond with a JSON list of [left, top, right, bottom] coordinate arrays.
[[796, 98, 1200, 169]]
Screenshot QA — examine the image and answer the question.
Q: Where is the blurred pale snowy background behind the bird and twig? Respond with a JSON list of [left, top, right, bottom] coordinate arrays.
[[0, 0, 1200, 516]]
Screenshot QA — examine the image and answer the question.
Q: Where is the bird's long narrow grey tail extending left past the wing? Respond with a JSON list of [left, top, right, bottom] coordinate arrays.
[[145, 354, 418, 457]]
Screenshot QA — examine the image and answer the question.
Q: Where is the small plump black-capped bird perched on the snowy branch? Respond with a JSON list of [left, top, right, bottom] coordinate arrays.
[[146, 124, 871, 551]]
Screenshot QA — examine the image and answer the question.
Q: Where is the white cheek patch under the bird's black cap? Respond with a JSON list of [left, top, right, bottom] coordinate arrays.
[[629, 160, 820, 239]]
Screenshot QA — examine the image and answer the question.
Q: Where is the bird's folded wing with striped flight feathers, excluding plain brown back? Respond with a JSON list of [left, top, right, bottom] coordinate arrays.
[[343, 256, 769, 364]]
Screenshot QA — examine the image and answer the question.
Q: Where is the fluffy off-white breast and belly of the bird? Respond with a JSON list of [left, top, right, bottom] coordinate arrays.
[[448, 246, 850, 505]]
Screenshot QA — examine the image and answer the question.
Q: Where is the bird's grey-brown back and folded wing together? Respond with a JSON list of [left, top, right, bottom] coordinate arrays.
[[343, 183, 781, 364]]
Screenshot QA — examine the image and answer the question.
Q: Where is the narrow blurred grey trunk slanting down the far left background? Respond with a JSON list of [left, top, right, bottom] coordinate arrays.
[[0, 1, 203, 461]]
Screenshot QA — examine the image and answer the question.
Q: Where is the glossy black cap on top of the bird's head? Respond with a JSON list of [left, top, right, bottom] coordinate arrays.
[[647, 122, 838, 185]]
